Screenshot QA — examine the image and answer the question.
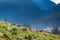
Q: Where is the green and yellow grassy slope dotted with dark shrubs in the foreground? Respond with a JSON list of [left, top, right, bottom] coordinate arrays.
[[0, 22, 60, 40]]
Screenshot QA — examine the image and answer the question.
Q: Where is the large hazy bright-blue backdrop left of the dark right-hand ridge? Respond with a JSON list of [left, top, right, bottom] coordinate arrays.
[[0, 0, 58, 29]]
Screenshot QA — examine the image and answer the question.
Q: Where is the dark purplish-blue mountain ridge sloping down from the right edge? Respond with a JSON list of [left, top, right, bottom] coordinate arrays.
[[38, 4, 60, 27]]
